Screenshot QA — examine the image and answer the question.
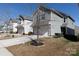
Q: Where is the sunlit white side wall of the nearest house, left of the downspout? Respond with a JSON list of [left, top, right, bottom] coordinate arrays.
[[50, 12, 64, 35]]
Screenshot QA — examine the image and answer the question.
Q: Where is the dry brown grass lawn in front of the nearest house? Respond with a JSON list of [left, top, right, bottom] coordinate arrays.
[[7, 38, 79, 56]]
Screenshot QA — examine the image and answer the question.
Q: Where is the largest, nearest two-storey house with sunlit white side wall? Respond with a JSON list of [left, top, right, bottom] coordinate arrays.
[[32, 6, 75, 36]]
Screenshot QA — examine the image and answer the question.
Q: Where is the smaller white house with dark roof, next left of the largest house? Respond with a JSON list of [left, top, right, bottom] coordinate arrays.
[[18, 15, 33, 34]]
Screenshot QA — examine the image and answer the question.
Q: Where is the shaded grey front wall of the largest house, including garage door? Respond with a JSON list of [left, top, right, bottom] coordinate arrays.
[[33, 10, 50, 35]]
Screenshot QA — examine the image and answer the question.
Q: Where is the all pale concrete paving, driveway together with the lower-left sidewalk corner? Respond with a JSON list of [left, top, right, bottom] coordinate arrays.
[[0, 36, 36, 56]]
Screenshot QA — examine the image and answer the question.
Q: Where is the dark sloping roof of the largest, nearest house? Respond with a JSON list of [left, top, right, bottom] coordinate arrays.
[[35, 6, 75, 22]]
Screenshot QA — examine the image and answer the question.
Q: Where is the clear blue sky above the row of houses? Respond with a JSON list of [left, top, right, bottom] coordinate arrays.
[[0, 3, 79, 26]]
